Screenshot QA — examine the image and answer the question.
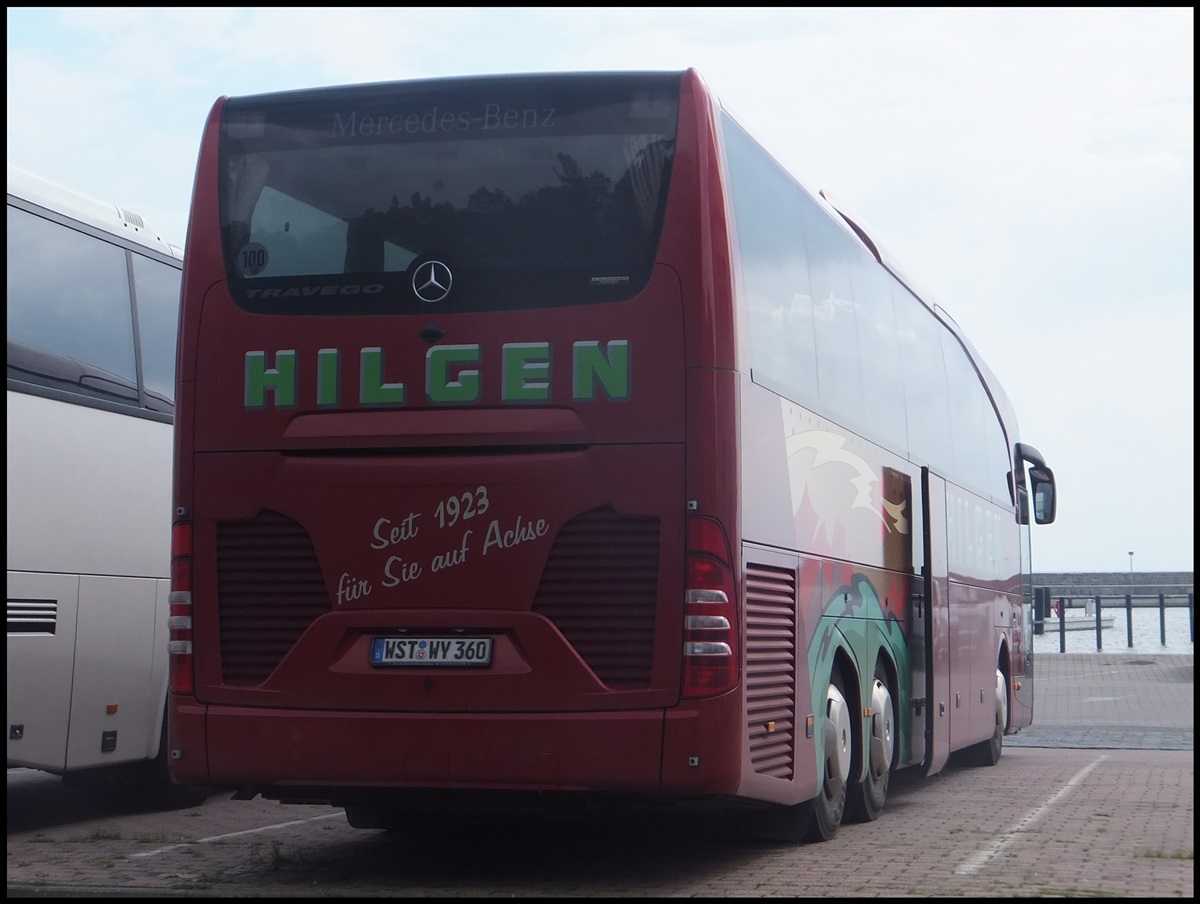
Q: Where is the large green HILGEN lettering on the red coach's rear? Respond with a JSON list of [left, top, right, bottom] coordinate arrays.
[[244, 339, 632, 411]]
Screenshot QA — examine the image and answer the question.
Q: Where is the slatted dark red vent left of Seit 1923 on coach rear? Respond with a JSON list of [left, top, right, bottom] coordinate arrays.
[[217, 511, 330, 687]]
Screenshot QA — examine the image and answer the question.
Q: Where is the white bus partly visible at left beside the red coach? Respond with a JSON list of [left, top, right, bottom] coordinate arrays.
[[7, 164, 197, 804]]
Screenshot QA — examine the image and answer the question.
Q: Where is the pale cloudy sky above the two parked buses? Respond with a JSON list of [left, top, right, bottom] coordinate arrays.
[[7, 6, 1195, 573]]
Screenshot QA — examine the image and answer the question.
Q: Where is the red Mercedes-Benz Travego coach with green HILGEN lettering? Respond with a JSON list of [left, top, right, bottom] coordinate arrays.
[[169, 70, 1055, 839]]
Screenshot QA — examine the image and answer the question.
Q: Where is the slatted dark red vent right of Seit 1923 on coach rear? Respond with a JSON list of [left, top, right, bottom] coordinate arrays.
[[533, 508, 659, 690]]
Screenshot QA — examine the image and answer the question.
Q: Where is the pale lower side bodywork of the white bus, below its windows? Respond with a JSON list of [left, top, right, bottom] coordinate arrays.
[[7, 391, 172, 772]]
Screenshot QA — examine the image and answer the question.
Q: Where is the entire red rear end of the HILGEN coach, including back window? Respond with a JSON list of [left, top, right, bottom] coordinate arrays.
[[172, 73, 740, 798]]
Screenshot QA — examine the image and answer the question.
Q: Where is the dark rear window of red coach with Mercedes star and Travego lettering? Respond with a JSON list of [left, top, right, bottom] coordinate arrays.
[[221, 73, 679, 313]]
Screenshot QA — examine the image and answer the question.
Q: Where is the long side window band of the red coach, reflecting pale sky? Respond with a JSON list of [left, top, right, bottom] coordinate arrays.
[[721, 114, 1010, 503]]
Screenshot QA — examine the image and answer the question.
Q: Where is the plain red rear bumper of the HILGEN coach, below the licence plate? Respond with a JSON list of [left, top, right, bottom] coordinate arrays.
[[169, 695, 742, 798]]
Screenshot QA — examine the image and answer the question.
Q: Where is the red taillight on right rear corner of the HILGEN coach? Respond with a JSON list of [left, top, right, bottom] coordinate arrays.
[[683, 516, 738, 698]]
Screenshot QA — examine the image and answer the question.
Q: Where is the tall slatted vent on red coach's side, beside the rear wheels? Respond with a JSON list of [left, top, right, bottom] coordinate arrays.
[[746, 564, 796, 779]]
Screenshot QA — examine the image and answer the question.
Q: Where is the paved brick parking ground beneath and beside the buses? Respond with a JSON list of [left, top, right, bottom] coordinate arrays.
[[7, 653, 1195, 899]]
